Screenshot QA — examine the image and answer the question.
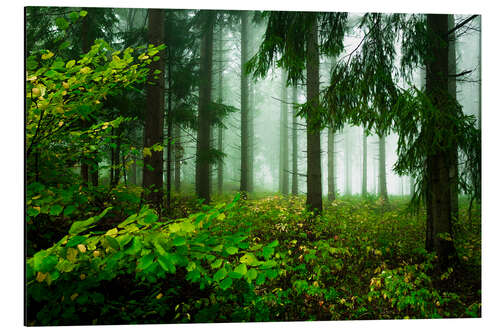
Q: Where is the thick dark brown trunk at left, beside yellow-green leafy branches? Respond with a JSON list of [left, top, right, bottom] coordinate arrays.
[[142, 9, 165, 209]]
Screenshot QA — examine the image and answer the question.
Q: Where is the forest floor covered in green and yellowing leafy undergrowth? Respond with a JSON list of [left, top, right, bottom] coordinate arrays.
[[27, 188, 481, 325]]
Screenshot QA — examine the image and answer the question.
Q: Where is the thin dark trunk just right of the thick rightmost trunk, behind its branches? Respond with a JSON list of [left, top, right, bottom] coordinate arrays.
[[448, 14, 458, 226]]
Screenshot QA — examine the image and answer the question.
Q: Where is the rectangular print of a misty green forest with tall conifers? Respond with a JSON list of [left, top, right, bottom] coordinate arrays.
[[25, 7, 481, 326]]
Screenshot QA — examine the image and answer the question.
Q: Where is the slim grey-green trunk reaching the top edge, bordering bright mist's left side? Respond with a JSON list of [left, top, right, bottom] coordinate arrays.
[[240, 11, 249, 192]]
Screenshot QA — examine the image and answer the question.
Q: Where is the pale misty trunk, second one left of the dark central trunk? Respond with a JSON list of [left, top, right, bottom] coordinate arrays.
[[280, 70, 290, 195]]
